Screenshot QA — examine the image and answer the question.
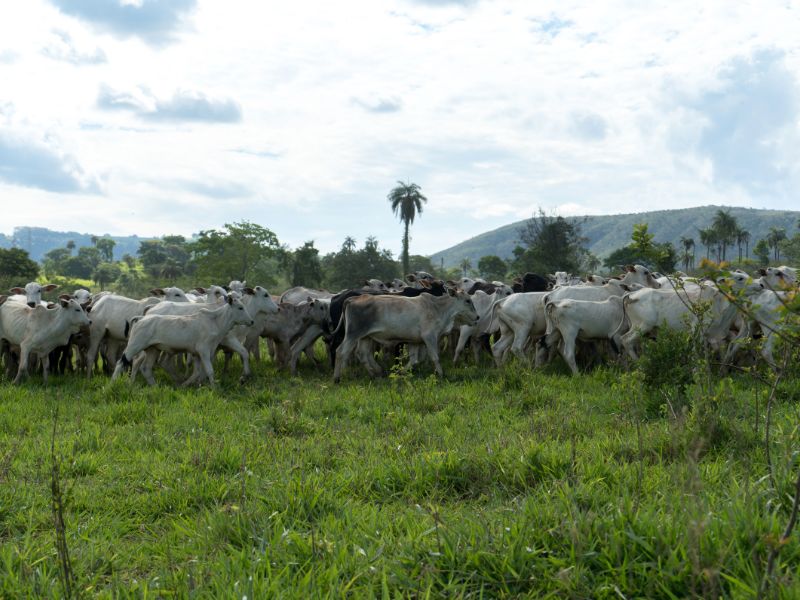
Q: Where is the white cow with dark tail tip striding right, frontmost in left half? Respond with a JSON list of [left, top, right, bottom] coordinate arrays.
[[112, 296, 253, 386]]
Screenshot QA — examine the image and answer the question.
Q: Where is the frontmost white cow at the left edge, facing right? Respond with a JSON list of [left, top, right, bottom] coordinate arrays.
[[0, 294, 90, 384]]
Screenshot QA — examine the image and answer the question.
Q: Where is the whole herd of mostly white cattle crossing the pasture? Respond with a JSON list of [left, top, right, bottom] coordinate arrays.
[[0, 265, 798, 385]]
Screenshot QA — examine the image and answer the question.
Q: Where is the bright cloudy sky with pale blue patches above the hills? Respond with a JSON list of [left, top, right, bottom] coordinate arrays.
[[0, 0, 800, 254]]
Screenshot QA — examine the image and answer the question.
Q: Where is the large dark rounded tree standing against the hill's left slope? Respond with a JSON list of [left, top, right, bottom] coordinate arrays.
[[511, 209, 586, 273]]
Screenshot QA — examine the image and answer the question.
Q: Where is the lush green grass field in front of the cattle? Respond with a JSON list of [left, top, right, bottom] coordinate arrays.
[[0, 350, 800, 599]]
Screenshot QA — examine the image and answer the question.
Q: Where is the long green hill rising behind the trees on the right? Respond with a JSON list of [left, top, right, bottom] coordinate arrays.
[[431, 206, 800, 268]]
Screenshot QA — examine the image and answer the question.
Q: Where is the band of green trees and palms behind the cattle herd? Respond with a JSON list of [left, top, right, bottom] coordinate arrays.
[[0, 190, 800, 295]]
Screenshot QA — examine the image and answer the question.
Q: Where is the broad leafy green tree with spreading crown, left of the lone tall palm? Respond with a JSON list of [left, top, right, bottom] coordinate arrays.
[[189, 221, 282, 285]]
